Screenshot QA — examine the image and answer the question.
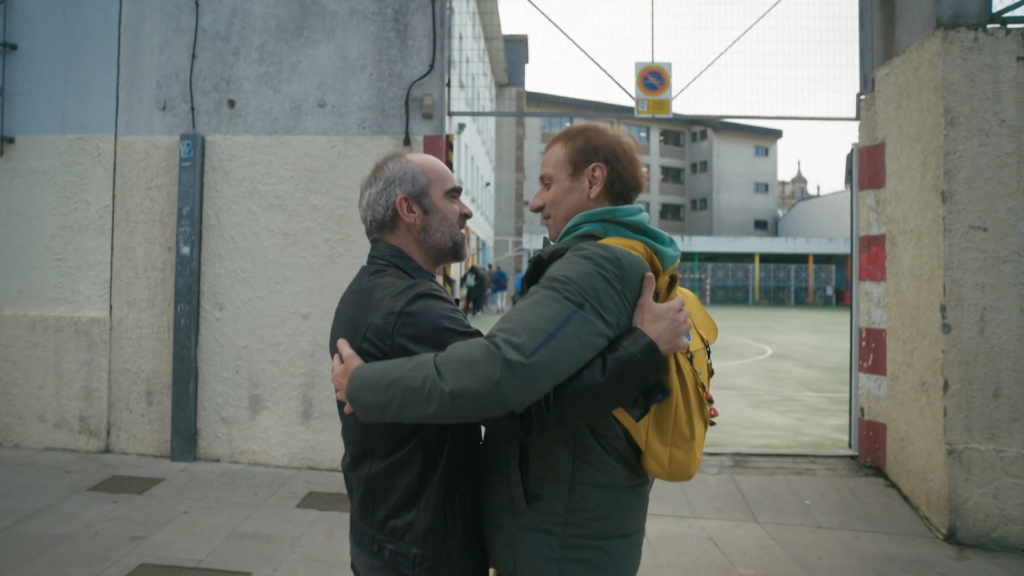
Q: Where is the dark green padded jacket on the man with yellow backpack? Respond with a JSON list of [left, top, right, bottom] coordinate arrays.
[[347, 242, 662, 576]]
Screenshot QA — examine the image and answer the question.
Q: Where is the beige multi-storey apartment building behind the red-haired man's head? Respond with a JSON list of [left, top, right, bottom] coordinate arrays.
[[523, 92, 782, 243]]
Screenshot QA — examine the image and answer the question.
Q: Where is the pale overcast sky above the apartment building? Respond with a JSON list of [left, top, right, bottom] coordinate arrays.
[[491, 0, 858, 193]]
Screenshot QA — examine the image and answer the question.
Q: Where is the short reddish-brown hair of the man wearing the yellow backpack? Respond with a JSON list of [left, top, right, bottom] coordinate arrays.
[[544, 123, 644, 206]]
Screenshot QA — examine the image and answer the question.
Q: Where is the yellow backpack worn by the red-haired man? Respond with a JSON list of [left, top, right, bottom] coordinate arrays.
[[601, 238, 718, 482]]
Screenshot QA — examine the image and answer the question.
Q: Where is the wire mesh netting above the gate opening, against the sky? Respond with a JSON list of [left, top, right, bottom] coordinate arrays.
[[450, 0, 859, 119]]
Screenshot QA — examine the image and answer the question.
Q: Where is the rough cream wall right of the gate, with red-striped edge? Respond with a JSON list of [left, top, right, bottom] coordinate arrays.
[[859, 29, 1024, 549]]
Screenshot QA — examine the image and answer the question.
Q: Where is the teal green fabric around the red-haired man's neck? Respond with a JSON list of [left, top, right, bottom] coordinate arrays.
[[556, 204, 680, 271]]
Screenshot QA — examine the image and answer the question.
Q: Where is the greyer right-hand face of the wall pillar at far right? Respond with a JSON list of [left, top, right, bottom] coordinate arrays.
[[941, 29, 1024, 550]]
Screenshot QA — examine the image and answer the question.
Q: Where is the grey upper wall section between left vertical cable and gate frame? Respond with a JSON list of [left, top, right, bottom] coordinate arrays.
[[118, 0, 447, 135]]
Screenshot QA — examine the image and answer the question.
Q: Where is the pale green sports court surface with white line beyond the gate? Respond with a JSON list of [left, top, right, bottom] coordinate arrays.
[[470, 306, 850, 452]]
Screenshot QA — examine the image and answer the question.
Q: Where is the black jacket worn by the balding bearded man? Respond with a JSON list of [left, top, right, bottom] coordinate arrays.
[[329, 241, 664, 576]]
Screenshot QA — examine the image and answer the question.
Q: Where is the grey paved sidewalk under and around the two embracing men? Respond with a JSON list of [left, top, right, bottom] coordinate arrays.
[[0, 449, 1024, 576]]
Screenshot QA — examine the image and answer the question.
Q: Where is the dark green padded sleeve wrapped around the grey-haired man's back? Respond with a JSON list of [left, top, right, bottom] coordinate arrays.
[[347, 242, 647, 423]]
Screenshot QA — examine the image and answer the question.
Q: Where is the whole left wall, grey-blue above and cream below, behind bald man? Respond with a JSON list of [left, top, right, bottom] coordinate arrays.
[[0, 0, 447, 468]]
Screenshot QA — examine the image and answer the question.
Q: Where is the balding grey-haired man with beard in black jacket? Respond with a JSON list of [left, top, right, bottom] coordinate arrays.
[[329, 154, 689, 576]]
